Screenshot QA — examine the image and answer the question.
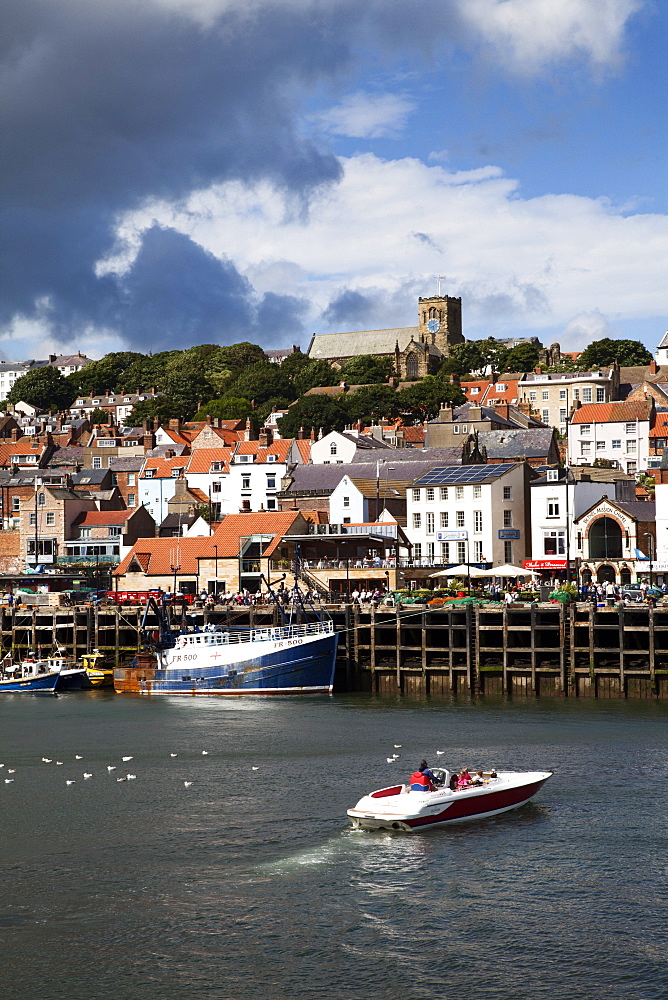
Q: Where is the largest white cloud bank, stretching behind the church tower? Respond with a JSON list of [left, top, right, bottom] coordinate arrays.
[[103, 154, 668, 347]]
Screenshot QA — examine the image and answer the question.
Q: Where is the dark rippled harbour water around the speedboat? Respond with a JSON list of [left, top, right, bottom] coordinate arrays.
[[0, 692, 668, 1000]]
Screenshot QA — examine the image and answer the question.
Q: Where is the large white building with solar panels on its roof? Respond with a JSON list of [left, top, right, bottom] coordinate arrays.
[[406, 462, 531, 566]]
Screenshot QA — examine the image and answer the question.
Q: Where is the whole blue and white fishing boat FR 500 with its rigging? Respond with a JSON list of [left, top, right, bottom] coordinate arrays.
[[114, 588, 338, 695]]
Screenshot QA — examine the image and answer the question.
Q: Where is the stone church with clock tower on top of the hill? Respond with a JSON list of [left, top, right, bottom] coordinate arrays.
[[307, 295, 464, 380]]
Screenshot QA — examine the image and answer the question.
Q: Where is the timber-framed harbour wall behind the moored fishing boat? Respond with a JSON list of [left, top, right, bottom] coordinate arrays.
[[5, 604, 668, 699]]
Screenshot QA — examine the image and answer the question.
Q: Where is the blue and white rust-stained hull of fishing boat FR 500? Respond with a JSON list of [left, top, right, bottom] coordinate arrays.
[[114, 632, 338, 696]]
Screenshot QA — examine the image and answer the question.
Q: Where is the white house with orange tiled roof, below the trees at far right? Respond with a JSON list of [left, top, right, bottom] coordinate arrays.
[[568, 398, 656, 474]]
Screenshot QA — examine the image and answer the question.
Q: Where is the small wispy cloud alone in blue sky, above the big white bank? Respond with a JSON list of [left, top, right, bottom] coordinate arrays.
[[314, 91, 416, 139]]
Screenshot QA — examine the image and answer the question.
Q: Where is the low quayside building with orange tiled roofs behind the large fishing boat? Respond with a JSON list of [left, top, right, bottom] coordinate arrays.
[[114, 511, 308, 594]]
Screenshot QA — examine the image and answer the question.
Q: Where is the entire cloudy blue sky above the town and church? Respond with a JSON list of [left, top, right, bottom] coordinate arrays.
[[0, 0, 668, 360]]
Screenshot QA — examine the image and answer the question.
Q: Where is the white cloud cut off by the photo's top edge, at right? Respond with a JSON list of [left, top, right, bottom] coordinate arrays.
[[457, 0, 644, 73]]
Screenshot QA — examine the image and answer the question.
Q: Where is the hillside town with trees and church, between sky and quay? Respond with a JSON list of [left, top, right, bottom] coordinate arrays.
[[0, 295, 668, 595]]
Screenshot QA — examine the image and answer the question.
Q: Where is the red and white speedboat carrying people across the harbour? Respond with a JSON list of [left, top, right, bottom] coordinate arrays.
[[348, 767, 552, 833]]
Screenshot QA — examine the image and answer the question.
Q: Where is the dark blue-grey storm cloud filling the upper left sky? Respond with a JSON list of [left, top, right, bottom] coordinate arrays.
[[0, 0, 460, 342]]
